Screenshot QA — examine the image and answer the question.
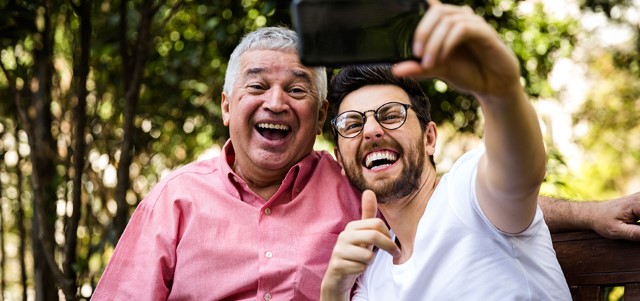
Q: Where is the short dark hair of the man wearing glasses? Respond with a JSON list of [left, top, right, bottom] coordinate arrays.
[[327, 64, 435, 166]]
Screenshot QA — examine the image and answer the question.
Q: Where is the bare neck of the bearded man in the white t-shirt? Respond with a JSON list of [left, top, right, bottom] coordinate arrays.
[[379, 167, 439, 264]]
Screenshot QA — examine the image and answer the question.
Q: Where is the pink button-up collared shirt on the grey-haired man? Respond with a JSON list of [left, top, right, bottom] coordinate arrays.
[[92, 142, 360, 300]]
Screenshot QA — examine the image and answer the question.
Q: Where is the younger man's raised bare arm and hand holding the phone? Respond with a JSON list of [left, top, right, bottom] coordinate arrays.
[[394, 1, 546, 233]]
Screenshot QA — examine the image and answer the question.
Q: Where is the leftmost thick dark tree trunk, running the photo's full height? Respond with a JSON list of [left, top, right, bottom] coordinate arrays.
[[25, 2, 69, 301]]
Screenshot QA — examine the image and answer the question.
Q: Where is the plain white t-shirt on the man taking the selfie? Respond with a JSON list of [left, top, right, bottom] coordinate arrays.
[[353, 150, 571, 301]]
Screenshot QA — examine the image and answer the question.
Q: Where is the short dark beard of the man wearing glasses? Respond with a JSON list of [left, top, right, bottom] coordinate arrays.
[[345, 141, 425, 204]]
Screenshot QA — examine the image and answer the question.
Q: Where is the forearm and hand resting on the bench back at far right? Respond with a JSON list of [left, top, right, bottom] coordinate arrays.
[[538, 192, 640, 241]]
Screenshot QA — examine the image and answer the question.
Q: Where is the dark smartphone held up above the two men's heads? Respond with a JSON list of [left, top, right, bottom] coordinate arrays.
[[291, 0, 428, 67]]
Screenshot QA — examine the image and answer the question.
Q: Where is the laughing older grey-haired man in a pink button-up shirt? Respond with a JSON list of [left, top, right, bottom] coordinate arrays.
[[93, 28, 360, 300]]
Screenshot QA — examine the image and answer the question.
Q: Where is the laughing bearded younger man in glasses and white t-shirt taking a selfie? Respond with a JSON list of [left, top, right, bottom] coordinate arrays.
[[321, 3, 571, 300]]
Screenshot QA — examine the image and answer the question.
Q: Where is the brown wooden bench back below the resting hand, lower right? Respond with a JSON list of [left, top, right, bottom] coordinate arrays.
[[552, 231, 640, 301]]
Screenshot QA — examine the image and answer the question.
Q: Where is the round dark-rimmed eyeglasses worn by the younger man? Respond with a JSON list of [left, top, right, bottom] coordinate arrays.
[[331, 102, 422, 138]]
